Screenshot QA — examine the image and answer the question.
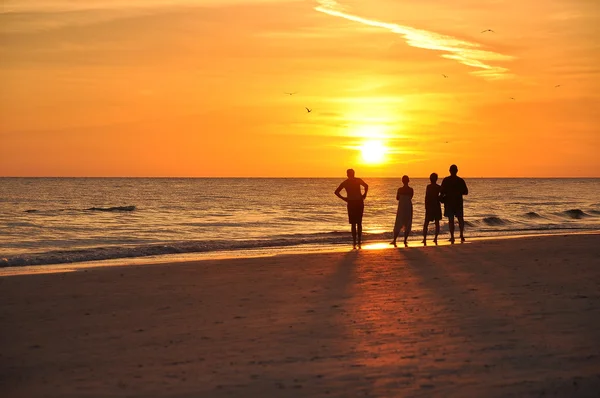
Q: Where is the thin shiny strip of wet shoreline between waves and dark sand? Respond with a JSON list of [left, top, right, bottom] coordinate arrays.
[[0, 230, 600, 278]]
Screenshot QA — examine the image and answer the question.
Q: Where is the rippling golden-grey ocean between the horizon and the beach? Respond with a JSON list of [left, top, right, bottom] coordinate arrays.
[[0, 178, 600, 266]]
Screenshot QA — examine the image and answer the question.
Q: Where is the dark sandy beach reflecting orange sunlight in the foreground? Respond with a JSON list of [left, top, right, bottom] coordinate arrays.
[[0, 234, 600, 397]]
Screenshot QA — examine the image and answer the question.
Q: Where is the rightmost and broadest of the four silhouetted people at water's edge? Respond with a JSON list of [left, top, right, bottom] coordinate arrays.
[[440, 164, 469, 243]]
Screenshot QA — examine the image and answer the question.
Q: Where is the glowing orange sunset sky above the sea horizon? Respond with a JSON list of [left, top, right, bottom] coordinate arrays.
[[0, 0, 600, 177]]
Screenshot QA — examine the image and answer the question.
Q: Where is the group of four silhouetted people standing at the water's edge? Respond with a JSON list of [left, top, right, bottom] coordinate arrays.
[[334, 164, 469, 249]]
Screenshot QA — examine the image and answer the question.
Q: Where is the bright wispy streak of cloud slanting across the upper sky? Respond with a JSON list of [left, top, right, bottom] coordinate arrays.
[[315, 0, 514, 79]]
